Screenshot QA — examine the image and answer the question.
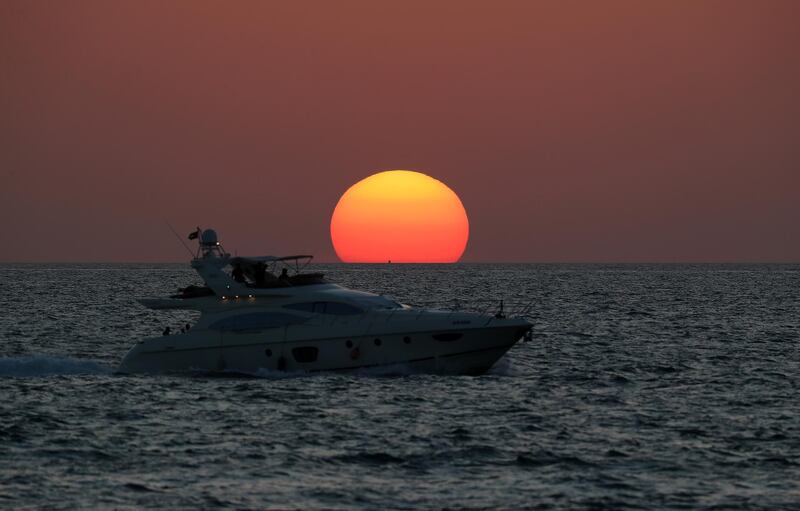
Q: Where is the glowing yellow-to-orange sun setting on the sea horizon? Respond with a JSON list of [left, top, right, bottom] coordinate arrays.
[[331, 170, 469, 263]]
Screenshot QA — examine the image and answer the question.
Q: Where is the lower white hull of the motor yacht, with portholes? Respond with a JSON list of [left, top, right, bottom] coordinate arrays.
[[119, 319, 531, 375]]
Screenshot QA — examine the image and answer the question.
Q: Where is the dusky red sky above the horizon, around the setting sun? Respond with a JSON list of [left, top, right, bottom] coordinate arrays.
[[0, 0, 800, 261]]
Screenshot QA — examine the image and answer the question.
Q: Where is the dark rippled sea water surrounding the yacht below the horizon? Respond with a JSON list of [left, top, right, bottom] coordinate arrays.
[[0, 264, 800, 510]]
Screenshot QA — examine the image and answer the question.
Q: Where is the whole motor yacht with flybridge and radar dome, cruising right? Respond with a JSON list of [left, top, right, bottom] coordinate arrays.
[[119, 228, 532, 375]]
